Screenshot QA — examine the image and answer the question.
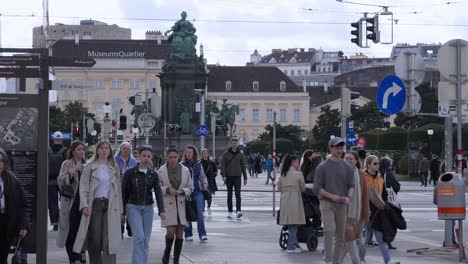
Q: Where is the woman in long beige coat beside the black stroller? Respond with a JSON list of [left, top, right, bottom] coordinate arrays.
[[278, 154, 305, 253]]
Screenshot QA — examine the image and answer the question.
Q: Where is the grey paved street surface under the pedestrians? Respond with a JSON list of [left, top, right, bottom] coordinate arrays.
[[17, 176, 468, 264]]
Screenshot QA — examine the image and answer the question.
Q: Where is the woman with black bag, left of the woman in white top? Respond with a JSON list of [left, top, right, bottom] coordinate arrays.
[[57, 140, 86, 264]]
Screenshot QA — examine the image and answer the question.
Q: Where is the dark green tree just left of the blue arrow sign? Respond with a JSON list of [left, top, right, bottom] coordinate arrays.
[[350, 101, 390, 132]]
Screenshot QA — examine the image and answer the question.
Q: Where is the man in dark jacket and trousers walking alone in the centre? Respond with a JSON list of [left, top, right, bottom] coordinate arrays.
[[221, 138, 247, 219]]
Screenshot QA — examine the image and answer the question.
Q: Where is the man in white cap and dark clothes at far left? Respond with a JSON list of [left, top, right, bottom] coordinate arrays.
[[48, 131, 68, 231]]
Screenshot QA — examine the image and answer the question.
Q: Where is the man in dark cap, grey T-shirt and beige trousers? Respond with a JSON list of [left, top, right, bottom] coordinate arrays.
[[314, 137, 354, 264]]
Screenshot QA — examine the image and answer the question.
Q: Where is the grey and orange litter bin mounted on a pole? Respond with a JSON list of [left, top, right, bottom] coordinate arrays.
[[437, 172, 466, 220]]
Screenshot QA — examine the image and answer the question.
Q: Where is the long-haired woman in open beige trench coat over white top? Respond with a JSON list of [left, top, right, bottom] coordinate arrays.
[[73, 141, 125, 264]]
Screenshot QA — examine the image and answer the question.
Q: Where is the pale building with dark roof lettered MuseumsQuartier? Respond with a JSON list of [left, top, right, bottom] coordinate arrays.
[[44, 36, 169, 134]]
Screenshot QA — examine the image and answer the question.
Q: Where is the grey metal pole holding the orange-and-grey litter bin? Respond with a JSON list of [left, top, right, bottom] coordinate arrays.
[[454, 40, 465, 261]]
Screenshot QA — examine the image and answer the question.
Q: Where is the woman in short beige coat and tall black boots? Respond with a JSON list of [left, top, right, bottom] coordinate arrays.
[[158, 149, 193, 264]]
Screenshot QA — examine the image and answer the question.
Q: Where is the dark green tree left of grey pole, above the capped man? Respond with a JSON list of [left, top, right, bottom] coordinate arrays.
[[312, 105, 340, 150]]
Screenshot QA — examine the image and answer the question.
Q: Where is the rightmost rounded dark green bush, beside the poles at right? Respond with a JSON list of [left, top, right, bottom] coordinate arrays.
[[408, 124, 445, 157]]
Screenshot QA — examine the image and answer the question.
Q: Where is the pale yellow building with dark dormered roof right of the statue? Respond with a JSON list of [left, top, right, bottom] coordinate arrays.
[[208, 66, 309, 142]]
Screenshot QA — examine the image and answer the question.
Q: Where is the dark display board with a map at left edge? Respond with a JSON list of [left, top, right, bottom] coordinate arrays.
[[0, 94, 39, 253]]
